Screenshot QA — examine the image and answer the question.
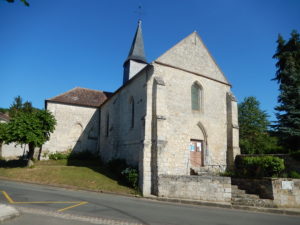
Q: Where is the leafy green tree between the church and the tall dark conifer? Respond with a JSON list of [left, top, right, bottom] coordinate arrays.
[[238, 97, 279, 154]]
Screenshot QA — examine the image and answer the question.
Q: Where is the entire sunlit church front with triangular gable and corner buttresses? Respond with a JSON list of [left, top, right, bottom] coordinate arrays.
[[143, 33, 239, 194]]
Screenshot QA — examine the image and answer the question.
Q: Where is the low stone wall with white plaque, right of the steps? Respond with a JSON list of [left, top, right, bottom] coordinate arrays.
[[232, 178, 300, 207]]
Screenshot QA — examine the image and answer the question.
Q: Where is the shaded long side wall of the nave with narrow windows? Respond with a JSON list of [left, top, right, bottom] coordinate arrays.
[[100, 68, 147, 167]]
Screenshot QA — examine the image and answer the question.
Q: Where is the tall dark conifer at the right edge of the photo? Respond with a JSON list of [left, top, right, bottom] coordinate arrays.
[[273, 31, 300, 151]]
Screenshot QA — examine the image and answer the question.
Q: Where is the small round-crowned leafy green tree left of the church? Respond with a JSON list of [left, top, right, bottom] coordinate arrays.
[[4, 110, 56, 164]]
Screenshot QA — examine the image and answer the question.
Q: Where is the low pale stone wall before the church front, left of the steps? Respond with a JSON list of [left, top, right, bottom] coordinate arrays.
[[158, 175, 231, 203]]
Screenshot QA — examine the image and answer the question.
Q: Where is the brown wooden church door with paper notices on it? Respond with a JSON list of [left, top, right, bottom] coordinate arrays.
[[190, 139, 203, 167]]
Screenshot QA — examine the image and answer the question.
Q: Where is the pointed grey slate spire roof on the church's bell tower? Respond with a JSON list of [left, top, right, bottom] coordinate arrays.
[[124, 20, 147, 64]]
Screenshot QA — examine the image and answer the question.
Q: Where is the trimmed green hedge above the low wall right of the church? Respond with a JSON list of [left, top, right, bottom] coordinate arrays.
[[235, 156, 285, 178]]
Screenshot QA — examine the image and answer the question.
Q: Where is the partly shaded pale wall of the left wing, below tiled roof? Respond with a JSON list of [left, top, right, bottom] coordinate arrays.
[[43, 102, 99, 153]]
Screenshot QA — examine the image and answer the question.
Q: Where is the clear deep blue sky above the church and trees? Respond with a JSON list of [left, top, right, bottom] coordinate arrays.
[[0, 0, 300, 119]]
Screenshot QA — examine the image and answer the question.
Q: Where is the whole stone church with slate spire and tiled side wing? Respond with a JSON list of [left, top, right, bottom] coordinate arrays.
[[43, 21, 240, 195]]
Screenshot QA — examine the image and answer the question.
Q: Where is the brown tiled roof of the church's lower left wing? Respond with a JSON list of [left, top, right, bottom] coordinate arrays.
[[46, 87, 112, 107]]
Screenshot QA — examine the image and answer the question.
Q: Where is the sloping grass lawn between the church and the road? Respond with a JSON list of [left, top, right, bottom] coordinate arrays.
[[0, 160, 137, 194]]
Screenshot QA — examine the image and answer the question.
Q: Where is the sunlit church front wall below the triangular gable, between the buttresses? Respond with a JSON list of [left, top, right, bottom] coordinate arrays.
[[152, 64, 230, 175]]
